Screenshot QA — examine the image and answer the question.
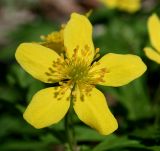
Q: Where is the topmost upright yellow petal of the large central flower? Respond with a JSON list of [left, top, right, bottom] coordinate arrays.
[[64, 13, 94, 62]]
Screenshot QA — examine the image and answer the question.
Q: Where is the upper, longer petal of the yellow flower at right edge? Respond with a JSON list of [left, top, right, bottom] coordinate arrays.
[[148, 14, 160, 52]]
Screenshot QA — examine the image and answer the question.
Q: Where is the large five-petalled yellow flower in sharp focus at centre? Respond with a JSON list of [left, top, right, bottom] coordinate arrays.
[[16, 13, 146, 135]]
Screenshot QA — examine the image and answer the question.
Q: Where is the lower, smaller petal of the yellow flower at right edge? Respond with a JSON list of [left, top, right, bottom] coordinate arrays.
[[144, 47, 160, 64]]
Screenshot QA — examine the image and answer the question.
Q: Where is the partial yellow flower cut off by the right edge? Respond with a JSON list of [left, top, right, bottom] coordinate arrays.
[[144, 14, 160, 64]]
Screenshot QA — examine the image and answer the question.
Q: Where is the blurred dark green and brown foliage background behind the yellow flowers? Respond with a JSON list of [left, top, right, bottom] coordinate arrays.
[[0, 0, 160, 151]]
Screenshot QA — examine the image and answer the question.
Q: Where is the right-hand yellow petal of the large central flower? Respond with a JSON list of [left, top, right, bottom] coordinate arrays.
[[92, 53, 147, 87]]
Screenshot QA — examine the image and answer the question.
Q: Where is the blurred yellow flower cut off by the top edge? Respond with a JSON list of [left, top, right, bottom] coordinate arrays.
[[100, 0, 141, 13]]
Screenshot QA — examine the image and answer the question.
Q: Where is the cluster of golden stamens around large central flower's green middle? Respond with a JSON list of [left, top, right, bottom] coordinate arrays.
[[45, 45, 108, 98]]
